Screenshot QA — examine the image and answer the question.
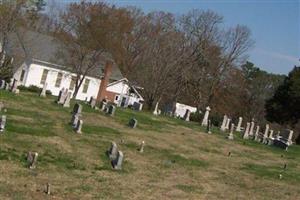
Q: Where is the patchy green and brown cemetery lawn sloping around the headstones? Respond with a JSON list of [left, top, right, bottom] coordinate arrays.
[[0, 91, 300, 200]]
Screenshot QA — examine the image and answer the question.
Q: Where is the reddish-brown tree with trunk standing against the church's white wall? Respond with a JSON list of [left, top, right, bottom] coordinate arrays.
[[55, 1, 131, 97]]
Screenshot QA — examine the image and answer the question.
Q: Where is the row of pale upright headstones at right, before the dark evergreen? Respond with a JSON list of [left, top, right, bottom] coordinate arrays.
[[220, 115, 293, 146]]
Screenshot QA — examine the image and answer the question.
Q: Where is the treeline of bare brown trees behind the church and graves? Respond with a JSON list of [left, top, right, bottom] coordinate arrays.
[[0, 0, 292, 134]]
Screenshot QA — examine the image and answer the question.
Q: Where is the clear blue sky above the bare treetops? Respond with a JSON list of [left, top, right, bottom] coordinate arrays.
[[50, 0, 300, 74]]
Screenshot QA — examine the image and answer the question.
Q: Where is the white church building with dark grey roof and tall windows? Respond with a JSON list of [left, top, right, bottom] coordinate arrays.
[[7, 31, 144, 107]]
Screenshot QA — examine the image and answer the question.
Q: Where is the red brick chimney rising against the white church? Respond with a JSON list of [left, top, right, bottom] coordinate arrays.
[[97, 61, 113, 102]]
